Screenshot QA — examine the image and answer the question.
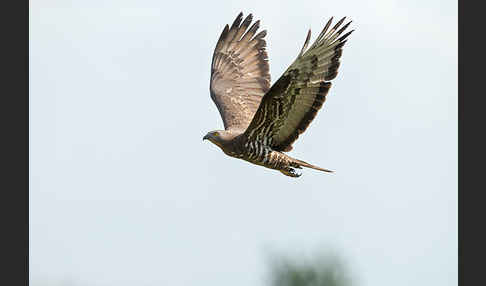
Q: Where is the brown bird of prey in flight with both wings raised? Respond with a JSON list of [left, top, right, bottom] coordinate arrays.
[[203, 13, 353, 177]]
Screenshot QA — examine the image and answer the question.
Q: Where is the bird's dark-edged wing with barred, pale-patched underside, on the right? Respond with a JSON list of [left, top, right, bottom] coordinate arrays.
[[245, 18, 353, 151]]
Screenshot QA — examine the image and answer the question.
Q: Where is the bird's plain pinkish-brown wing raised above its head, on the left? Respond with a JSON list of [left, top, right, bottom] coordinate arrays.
[[209, 13, 270, 132]]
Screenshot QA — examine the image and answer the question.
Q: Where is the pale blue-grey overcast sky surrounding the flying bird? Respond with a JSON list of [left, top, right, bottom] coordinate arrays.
[[29, 0, 458, 286]]
